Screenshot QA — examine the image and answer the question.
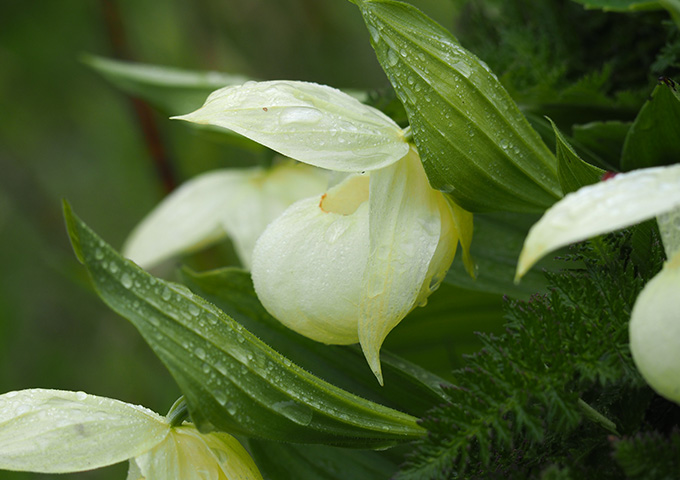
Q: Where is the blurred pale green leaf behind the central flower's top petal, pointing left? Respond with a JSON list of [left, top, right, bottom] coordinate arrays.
[[83, 55, 249, 115]]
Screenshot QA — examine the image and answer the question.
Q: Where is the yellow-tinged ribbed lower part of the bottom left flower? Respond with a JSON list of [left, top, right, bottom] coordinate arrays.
[[127, 425, 262, 480]]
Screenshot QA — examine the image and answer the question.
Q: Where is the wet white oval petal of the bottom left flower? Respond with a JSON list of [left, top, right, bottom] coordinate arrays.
[[0, 389, 170, 473]]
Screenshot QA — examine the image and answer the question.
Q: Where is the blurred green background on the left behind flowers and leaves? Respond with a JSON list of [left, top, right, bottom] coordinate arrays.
[[0, 0, 457, 480]]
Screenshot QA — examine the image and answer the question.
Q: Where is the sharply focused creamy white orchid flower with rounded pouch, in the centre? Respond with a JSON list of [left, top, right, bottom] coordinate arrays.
[[179, 81, 472, 383]]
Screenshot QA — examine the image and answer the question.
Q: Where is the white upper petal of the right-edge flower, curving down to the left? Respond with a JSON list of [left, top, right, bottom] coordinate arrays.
[[517, 165, 680, 278]]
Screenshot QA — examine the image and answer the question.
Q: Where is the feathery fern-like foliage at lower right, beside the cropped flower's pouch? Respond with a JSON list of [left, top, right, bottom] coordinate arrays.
[[397, 231, 676, 480]]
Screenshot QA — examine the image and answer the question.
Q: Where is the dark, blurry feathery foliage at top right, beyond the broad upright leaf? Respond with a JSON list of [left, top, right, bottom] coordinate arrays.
[[453, 0, 674, 122]]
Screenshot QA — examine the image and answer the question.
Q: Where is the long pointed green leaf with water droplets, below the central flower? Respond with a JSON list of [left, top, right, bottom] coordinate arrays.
[[65, 205, 422, 447]]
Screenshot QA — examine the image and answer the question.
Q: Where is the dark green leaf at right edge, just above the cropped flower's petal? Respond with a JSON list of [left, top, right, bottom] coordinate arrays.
[[621, 79, 680, 171]]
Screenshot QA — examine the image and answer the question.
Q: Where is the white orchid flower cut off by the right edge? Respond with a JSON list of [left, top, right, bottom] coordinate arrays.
[[517, 165, 680, 403]]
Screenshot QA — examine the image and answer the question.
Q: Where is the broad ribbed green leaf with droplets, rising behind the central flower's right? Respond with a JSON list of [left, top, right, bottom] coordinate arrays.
[[355, 0, 561, 212]]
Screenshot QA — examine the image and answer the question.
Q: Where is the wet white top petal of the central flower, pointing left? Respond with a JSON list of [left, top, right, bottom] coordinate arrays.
[[176, 81, 409, 172]]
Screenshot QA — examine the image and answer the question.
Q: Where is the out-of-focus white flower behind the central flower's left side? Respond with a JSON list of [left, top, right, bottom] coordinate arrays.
[[123, 160, 328, 268]]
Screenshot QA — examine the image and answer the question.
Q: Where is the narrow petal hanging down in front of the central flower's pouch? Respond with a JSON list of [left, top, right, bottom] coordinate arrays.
[[359, 151, 444, 383]]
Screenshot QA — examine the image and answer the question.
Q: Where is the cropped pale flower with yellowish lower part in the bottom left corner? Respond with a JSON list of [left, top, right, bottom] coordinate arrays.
[[0, 389, 262, 480]]
